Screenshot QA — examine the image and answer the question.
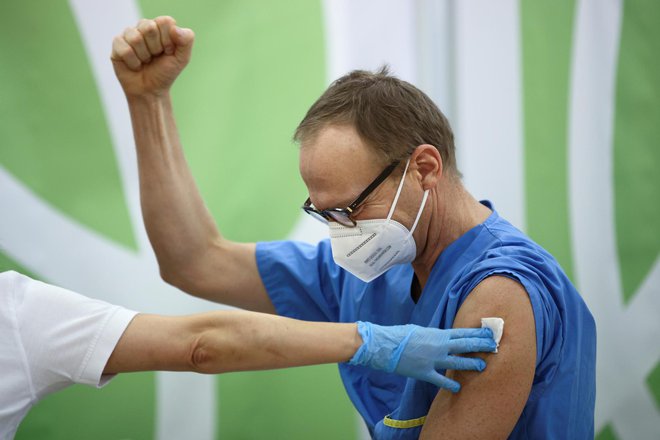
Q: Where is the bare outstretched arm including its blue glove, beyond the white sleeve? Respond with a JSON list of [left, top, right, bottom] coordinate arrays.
[[105, 311, 495, 384]]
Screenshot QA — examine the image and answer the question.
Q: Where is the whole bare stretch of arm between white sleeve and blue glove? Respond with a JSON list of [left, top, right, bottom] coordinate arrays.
[[105, 311, 362, 373]]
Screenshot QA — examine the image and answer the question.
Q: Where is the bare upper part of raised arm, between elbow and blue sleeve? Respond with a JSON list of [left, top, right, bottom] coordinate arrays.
[[161, 239, 275, 313]]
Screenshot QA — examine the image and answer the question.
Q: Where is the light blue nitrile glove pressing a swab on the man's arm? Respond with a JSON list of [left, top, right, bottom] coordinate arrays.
[[348, 321, 497, 393]]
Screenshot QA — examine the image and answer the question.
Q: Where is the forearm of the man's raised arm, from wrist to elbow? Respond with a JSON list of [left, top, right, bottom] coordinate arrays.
[[128, 93, 220, 272]]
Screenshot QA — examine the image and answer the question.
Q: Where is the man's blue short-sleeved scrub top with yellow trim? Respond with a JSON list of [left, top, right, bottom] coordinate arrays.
[[256, 202, 596, 439]]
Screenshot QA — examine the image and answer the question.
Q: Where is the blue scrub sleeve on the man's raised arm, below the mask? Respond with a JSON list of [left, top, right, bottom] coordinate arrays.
[[256, 240, 343, 322]]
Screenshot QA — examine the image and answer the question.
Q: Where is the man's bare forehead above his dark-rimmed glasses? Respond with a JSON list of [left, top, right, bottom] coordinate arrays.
[[300, 125, 382, 208]]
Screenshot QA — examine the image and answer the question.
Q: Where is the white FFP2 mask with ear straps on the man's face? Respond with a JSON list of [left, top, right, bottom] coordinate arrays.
[[328, 159, 429, 283]]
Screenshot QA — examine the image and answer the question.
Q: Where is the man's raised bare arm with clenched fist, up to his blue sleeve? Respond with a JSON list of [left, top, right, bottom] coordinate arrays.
[[111, 17, 274, 313]]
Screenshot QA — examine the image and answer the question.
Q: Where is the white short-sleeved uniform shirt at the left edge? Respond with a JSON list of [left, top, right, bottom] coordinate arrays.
[[0, 271, 137, 440]]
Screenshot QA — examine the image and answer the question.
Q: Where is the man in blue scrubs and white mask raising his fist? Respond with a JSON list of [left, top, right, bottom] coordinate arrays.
[[112, 17, 596, 439]]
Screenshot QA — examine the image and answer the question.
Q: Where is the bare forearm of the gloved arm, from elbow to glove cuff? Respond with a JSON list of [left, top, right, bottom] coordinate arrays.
[[193, 311, 362, 373]]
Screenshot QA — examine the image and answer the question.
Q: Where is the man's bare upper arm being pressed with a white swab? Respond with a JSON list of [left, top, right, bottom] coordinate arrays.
[[420, 276, 536, 439]]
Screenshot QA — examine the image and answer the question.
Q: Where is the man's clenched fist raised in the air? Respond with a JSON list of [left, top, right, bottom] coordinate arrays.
[[110, 16, 195, 96]]
